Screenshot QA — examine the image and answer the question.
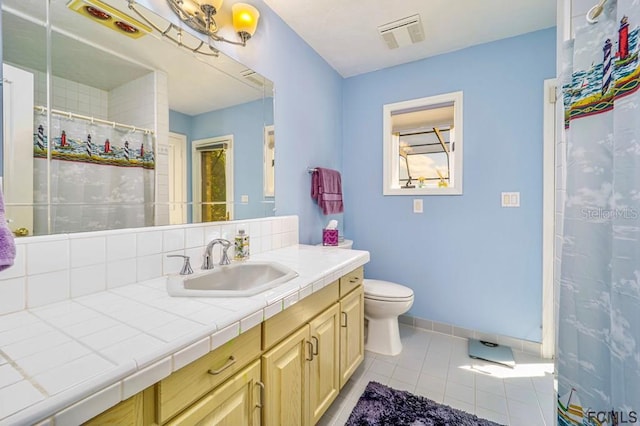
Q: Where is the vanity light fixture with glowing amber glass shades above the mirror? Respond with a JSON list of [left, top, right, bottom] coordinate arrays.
[[127, 0, 260, 56]]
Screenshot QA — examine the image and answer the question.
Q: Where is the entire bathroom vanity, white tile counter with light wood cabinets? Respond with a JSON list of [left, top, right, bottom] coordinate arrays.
[[0, 223, 369, 425]]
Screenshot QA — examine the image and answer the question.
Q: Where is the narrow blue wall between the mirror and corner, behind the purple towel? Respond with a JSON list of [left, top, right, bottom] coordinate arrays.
[[139, 0, 343, 243]]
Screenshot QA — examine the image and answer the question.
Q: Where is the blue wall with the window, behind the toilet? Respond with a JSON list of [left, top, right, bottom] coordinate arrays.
[[343, 28, 555, 341]]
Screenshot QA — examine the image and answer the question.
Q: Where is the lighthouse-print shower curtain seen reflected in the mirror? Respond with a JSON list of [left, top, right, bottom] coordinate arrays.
[[33, 112, 155, 235]]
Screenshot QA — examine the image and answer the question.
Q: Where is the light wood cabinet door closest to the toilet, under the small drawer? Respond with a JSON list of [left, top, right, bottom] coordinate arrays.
[[340, 286, 364, 389]]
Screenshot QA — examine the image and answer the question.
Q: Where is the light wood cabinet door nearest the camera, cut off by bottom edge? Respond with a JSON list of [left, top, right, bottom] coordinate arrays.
[[168, 360, 262, 426]]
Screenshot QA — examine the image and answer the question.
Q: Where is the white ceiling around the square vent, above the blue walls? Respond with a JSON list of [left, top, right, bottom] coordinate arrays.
[[264, 0, 556, 77]]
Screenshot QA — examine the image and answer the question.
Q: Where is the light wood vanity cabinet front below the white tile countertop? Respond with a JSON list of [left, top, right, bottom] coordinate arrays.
[[88, 267, 364, 425]]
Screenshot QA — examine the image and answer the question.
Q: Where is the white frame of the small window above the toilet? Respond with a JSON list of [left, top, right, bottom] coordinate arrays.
[[382, 91, 464, 196]]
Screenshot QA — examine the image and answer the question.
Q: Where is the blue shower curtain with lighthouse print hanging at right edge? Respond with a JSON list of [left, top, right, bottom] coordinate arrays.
[[556, 0, 640, 425]]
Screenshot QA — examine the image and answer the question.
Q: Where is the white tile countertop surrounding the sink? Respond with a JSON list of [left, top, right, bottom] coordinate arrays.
[[0, 245, 369, 425]]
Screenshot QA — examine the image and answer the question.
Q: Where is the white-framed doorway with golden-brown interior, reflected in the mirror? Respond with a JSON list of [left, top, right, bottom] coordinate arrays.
[[192, 135, 233, 222]]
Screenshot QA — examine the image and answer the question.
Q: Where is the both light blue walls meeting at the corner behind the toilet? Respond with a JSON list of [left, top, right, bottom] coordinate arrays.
[[142, 0, 555, 341]]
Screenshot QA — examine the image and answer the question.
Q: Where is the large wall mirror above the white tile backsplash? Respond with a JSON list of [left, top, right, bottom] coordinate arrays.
[[1, 0, 275, 235]]
